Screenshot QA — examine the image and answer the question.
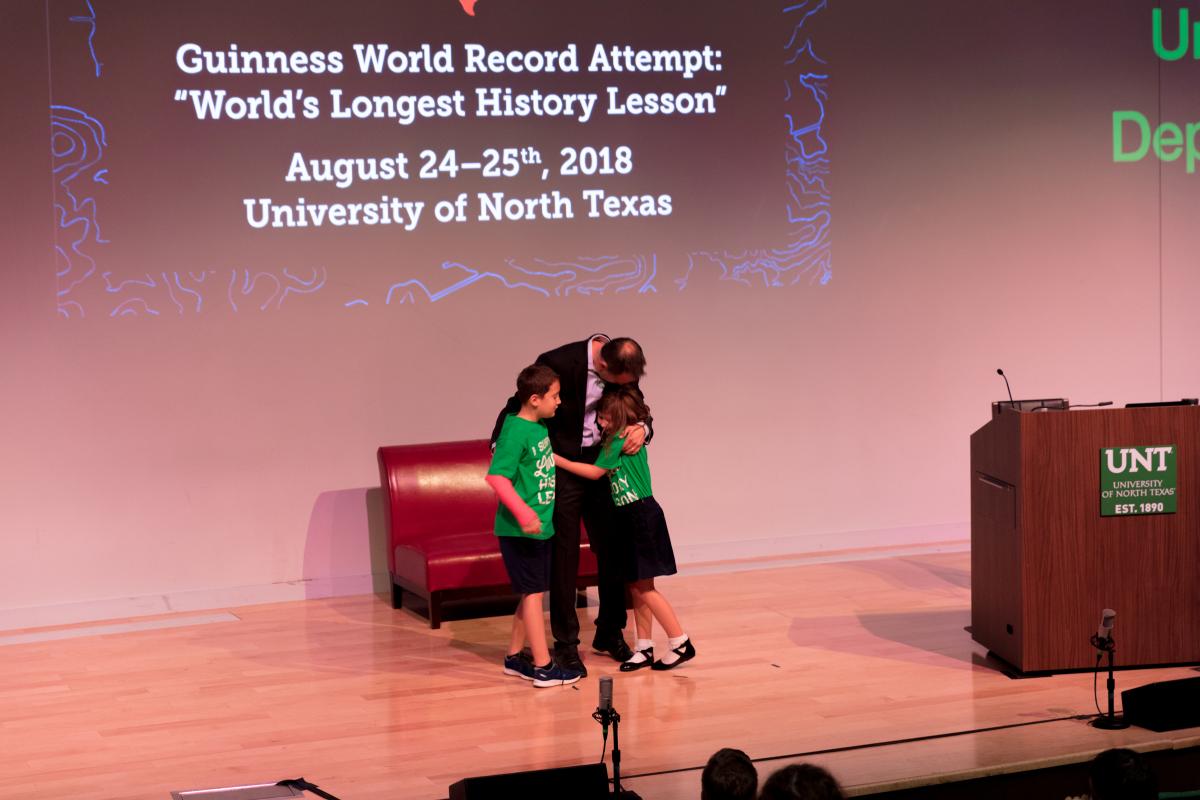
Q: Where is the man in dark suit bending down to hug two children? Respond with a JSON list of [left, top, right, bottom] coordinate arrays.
[[492, 333, 652, 675]]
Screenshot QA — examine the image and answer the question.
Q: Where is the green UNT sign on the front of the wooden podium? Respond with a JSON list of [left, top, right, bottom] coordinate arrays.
[[1100, 445, 1177, 517]]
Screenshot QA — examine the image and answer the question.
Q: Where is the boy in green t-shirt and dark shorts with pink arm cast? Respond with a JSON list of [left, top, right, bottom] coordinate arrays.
[[486, 365, 582, 688]]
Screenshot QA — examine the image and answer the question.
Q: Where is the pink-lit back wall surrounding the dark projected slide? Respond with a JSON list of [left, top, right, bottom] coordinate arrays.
[[0, 0, 1200, 609]]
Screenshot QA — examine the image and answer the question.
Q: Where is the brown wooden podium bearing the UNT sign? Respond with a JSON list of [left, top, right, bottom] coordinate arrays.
[[971, 405, 1200, 673]]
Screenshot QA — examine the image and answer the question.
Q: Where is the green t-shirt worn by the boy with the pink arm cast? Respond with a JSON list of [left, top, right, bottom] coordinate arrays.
[[487, 414, 554, 539]]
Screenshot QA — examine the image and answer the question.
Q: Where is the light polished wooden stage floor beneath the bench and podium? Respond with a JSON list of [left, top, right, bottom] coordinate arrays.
[[0, 552, 1200, 800]]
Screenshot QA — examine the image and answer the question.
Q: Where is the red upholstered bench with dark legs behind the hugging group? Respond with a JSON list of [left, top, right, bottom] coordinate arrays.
[[379, 439, 596, 627]]
